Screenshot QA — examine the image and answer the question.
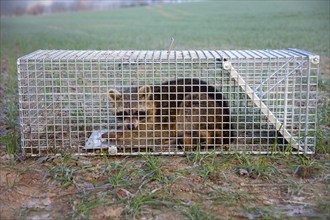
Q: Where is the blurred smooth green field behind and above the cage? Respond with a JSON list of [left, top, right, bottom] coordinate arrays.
[[1, 1, 330, 52]]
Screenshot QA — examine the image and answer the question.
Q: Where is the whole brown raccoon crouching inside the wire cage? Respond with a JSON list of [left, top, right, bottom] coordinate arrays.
[[102, 79, 231, 150]]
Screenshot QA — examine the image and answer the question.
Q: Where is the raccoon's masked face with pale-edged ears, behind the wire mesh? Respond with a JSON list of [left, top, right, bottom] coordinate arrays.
[[109, 86, 155, 130]]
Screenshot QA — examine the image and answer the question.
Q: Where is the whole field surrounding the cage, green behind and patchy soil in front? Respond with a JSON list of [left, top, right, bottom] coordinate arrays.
[[0, 0, 330, 220]]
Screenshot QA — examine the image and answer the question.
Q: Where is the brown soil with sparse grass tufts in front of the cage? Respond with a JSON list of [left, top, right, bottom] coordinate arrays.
[[0, 55, 330, 220]]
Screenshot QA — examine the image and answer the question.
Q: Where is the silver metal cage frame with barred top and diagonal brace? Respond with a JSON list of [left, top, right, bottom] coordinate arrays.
[[17, 48, 319, 156]]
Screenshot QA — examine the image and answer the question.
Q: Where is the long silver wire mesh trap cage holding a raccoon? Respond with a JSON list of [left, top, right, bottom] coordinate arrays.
[[17, 49, 319, 156]]
